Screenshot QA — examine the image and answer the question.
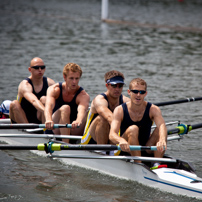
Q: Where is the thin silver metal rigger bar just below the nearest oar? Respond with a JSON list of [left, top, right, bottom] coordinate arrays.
[[48, 154, 177, 163]]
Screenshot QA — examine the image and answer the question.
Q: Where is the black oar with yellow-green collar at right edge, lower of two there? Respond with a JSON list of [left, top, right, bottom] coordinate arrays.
[[168, 123, 202, 135]]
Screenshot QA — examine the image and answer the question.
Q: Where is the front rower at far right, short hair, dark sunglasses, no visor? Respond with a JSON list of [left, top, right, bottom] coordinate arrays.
[[109, 78, 167, 163]]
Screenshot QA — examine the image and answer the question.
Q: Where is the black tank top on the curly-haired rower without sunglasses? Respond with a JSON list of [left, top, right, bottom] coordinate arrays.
[[53, 82, 83, 123]]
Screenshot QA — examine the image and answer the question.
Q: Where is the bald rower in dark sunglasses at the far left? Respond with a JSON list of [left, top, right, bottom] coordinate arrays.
[[10, 57, 55, 124]]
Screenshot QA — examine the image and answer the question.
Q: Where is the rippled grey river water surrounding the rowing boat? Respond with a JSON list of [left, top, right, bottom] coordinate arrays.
[[0, 0, 202, 202]]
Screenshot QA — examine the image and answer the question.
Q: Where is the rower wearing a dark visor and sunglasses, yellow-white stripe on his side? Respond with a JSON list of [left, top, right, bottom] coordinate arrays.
[[81, 70, 130, 144]]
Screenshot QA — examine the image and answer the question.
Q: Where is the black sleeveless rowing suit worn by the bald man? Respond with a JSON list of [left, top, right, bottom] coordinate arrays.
[[20, 77, 48, 123]]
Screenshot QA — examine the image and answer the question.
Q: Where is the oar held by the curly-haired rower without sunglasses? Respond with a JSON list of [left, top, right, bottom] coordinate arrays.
[[0, 123, 72, 129]]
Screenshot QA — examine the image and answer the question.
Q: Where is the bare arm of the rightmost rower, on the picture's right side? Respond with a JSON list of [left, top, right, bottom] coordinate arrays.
[[150, 105, 167, 151]]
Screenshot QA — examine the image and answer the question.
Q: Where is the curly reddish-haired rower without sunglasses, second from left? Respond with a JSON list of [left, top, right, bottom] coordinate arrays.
[[44, 63, 90, 142]]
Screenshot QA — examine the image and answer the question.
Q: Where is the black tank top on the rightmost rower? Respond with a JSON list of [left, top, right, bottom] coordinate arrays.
[[121, 102, 152, 146]]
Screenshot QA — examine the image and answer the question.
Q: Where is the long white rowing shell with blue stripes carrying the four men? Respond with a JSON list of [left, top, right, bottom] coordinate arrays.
[[0, 130, 202, 199]]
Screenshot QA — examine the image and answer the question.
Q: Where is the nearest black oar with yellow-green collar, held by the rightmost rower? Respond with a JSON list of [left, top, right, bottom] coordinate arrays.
[[0, 143, 161, 153]]
